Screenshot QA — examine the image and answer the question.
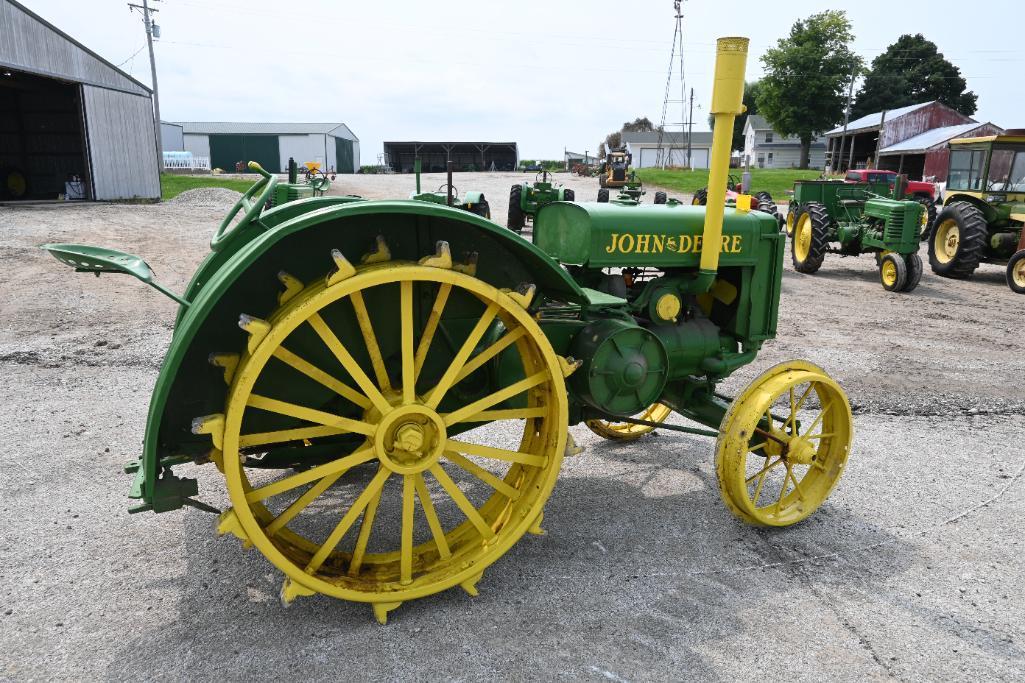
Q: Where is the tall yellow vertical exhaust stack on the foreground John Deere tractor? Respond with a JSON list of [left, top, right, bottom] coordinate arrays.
[[700, 38, 750, 288]]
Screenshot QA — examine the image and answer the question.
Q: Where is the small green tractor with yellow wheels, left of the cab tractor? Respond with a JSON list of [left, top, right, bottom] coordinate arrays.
[[790, 175, 924, 292]]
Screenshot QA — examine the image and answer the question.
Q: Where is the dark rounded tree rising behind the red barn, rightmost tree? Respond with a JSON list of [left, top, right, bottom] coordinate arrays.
[[851, 33, 979, 117]]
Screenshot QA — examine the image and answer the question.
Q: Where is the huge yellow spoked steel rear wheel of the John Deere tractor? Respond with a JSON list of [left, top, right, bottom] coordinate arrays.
[[220, 263, 567, 622]]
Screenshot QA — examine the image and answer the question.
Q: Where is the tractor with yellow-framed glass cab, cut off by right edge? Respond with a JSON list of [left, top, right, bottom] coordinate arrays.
[[929, 131, 1025, 294]]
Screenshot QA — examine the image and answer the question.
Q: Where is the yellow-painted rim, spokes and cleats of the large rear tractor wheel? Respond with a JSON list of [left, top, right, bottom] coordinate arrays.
[[215, 256, 576, 622]]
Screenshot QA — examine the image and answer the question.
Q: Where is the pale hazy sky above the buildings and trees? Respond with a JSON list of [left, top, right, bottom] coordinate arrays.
[[22, 0, 1025, 164]]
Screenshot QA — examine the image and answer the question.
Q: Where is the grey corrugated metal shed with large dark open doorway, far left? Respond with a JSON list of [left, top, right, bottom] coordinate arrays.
[[0, 0, 160, 200]]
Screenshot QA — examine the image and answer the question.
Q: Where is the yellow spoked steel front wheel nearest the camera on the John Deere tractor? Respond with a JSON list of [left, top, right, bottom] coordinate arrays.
[[715, 361, 854, 526]]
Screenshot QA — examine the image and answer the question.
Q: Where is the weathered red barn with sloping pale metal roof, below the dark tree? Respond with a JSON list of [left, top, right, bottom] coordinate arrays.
[[825, 101, 979, 179]]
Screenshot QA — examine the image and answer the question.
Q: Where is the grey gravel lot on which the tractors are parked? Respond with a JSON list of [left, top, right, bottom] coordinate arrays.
[[0, 173, 1025, 681]]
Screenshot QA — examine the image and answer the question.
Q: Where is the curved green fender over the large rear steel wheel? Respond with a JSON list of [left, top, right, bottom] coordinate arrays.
[[136, 198, 586, 504]]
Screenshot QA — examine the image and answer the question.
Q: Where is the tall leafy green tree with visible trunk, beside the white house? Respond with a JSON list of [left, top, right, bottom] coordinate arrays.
[[756, 9, 861, 168]]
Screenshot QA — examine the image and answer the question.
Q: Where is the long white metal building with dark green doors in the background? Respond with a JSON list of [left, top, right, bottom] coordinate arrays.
[[179, 121, 360, 173]]
